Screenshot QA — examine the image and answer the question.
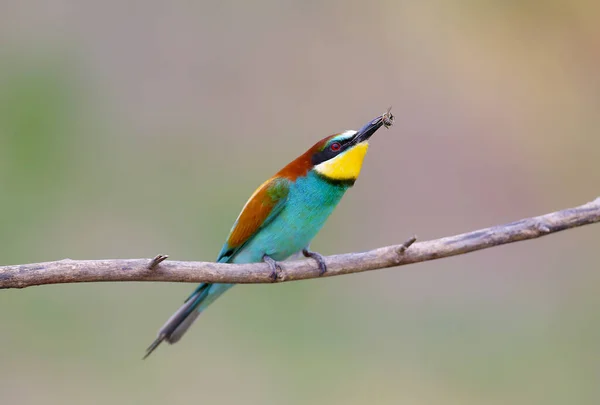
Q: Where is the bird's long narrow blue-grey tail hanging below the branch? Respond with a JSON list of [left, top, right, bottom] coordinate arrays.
[[144, 283, 233, 359]]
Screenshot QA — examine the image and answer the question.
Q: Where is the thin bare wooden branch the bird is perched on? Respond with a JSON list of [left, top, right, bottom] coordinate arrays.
[[0, 197, 600, 288]]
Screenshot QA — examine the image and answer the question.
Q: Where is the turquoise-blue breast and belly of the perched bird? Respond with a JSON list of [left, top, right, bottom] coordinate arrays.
[[231, 171, 349, 263]]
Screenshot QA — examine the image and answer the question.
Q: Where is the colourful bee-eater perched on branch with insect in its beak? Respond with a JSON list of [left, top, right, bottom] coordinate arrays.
[[144, 107, 394, 359]]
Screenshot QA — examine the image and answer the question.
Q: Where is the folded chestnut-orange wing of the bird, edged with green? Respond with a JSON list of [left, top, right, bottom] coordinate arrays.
[[217, 177, 290, 262]]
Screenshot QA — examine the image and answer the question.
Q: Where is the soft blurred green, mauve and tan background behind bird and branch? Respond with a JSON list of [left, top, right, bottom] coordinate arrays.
[[0, 0, 600, 405]]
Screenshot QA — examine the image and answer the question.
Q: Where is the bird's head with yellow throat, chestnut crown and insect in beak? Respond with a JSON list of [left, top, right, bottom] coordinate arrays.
[[278, 110, 394, 185]]
